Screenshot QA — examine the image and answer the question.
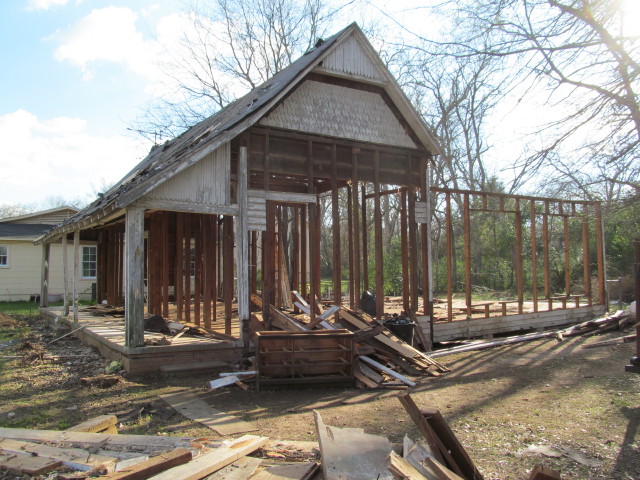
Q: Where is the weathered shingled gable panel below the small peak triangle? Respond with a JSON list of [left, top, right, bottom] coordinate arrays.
[[260, 80, 416, 148]]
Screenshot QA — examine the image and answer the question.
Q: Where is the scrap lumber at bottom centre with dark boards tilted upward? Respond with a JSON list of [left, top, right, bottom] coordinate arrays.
[[314, 393, 560, 480]]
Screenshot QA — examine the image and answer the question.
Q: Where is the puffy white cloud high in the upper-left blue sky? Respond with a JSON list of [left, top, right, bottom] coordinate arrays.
[[53, 6, 162, 79]]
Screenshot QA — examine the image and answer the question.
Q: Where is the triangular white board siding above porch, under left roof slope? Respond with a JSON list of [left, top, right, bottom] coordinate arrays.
[[144, 143, 231, 205]]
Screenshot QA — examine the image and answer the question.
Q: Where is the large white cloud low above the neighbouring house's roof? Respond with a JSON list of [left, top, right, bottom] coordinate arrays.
[[0, 110, 148, 204]]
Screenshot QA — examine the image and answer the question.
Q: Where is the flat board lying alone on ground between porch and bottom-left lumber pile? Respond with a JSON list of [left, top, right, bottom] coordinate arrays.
[[160, 391, 258, 435]]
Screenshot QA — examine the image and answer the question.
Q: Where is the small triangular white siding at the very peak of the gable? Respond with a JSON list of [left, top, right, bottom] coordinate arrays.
[[316, 35, 385, 83]]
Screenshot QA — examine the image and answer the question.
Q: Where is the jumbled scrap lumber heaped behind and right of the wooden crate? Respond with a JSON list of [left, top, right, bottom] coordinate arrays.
[[251, 292, 449, 389]]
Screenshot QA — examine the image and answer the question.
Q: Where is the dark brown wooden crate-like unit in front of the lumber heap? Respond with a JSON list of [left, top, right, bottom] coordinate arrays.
[[256, 330, 354, 389]]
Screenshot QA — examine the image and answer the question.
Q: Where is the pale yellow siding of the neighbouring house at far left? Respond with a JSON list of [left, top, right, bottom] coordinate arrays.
[[0, 241, 95, 301]]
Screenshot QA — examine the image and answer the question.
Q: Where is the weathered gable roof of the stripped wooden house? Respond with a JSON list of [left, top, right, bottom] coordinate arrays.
[[38, 23, 440, 242]]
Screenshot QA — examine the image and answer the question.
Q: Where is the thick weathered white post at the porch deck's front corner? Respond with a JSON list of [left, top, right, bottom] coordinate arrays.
[[124, 207, 144, 347]]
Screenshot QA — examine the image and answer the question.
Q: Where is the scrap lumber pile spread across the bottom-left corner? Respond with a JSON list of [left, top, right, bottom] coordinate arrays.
[[0, 428, 296, 480]]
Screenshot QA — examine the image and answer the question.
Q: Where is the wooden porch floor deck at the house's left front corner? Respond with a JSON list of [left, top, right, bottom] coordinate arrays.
[[40, 307, 244, 374]]
